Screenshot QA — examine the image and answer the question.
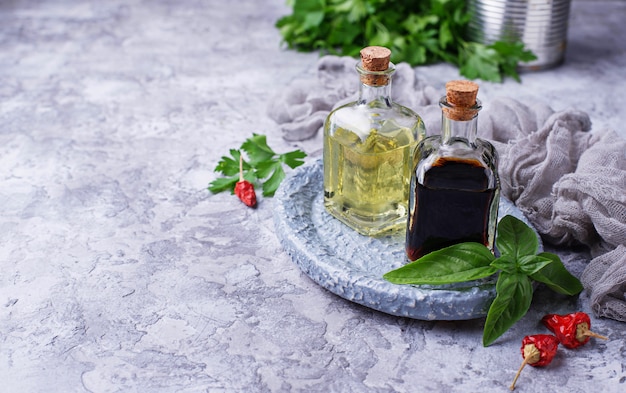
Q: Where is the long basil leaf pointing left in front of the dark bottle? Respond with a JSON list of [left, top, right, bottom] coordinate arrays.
[[383, 242, 498, 285]]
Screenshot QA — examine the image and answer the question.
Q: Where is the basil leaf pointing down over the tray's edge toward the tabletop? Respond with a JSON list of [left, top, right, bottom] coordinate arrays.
[[483, 272, 533, 347]]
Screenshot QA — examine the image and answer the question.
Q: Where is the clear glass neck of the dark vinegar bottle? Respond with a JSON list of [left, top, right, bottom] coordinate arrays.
[[439, 97, 482, 146]]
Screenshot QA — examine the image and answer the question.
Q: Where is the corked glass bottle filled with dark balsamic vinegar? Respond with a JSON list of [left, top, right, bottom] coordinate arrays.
[[406, 81, 500, 261]]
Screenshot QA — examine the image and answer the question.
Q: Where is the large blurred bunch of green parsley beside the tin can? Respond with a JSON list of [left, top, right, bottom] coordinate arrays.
[[276, 0, 536, 82]]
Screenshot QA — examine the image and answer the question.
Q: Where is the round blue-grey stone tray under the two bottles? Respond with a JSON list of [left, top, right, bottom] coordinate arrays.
[[274, 160, 541, 320]]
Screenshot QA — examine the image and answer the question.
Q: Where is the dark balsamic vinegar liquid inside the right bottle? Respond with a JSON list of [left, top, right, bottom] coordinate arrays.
[[406, 157, 496, 261]]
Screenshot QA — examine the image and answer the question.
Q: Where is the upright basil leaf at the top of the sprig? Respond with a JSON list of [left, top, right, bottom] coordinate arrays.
[[496, 215, 539, 259]]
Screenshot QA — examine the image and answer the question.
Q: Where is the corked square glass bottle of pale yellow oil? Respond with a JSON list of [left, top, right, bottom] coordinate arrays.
[[323, 46, 425, 236]]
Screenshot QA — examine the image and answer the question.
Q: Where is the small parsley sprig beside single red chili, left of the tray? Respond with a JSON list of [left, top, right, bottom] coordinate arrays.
[[209, 134, 306, 197]]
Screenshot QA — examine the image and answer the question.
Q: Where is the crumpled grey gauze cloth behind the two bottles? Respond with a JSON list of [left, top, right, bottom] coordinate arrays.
[[268, 56, 626, 321]]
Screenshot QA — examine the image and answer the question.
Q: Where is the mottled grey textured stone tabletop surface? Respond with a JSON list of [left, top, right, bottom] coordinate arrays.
[[0, 0, 626, 392]]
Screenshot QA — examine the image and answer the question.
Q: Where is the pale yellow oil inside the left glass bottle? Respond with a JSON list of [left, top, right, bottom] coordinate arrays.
[[324, 122, 417, 236]]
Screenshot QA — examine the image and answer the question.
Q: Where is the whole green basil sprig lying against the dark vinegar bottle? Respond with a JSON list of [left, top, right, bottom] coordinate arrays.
[[384, 215, 583, 346]]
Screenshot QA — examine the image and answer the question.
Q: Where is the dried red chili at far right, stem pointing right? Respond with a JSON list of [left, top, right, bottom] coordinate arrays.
[[541, 311, 608, 349]]
